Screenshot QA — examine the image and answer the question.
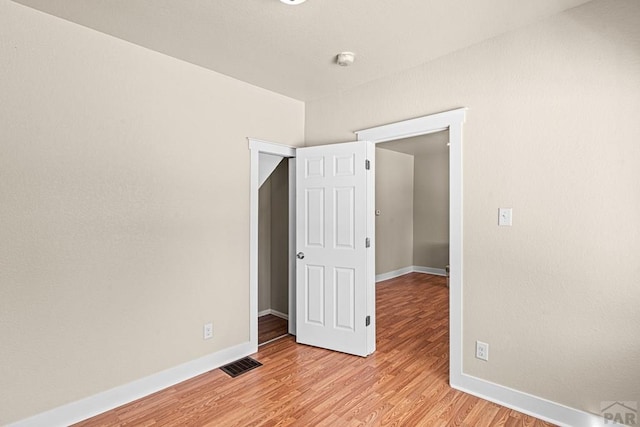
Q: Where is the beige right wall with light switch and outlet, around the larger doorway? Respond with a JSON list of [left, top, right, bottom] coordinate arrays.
[[305, 0, 640, 412]]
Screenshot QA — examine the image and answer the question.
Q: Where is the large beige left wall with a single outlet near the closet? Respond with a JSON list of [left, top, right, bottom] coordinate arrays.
[[0, 0, 304, 425]]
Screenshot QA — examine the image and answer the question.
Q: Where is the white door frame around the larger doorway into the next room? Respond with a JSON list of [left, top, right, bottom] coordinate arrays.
[[356, 108, 467, 387]]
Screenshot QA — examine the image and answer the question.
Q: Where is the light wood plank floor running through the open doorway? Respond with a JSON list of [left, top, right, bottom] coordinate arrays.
[[79, 273, 551, 427]]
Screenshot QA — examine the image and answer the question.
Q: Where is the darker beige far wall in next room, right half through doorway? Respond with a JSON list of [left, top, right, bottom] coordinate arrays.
[[413, 146, 449, 269]]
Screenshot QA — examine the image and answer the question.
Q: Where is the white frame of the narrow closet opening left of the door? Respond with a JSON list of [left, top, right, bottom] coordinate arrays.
[[247, 138, 296, 353]]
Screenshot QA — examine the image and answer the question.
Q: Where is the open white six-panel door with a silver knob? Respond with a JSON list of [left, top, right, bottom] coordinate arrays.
[[296, 142, 375, 356]]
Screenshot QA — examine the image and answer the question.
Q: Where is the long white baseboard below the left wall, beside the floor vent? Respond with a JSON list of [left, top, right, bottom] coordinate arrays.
[[8, 342, 257, 427]]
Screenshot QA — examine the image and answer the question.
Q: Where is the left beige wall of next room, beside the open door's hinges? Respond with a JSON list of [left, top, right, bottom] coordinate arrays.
[[376, 148, 413, 274]]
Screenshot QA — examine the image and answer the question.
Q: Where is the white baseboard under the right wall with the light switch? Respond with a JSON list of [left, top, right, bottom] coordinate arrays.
[[450, 374, 615, 427]]
